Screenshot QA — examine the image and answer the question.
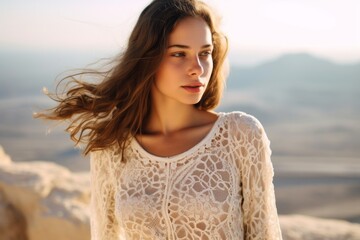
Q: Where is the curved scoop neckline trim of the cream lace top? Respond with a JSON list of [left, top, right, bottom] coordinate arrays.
[[131, 112, 224, 162]]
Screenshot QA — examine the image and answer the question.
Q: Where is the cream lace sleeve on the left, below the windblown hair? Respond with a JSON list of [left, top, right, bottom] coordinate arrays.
[[90, 151, 118, 240]]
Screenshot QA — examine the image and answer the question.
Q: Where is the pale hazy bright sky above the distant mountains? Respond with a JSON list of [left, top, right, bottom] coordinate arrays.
[[0, 0, 360, 63]]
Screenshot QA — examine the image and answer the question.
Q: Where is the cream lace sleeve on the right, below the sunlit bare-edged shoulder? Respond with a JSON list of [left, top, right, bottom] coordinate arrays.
[[232, 115, 282, 240]]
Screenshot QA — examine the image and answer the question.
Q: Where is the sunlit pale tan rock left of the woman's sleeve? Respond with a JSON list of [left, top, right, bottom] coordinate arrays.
[[0, 146, 90, 240]]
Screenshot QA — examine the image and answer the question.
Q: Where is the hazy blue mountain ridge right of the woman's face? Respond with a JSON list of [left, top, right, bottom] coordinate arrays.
[[227, 53, 360, 91]]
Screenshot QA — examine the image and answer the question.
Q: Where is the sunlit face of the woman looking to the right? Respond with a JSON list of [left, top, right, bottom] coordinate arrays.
[[152, 17, 213, 105]]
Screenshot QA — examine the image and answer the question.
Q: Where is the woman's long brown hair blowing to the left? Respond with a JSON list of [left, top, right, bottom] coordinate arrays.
[[35, 0, 228, 157]]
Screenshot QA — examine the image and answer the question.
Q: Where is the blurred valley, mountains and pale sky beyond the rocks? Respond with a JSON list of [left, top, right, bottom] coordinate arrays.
[[0, 0, 360, 223]]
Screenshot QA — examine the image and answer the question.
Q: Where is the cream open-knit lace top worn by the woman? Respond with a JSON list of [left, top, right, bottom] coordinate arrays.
[[91, 112, 282, 240]]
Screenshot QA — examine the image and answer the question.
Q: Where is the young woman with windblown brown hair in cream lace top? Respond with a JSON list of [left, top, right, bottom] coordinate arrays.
[[38, 0, 281, 240]]
